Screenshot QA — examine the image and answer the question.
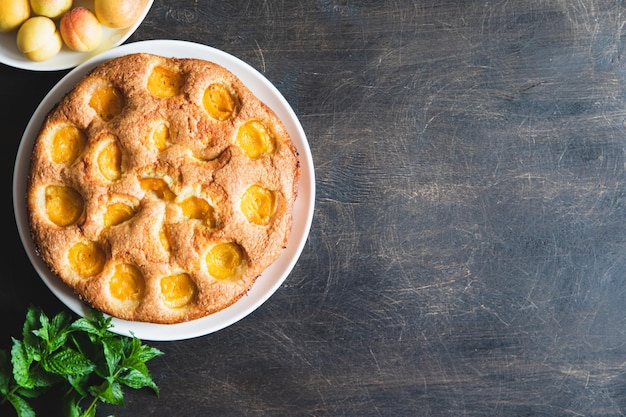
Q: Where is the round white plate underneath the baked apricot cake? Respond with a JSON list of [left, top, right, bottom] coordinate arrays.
[[13, 40, 315, 341]]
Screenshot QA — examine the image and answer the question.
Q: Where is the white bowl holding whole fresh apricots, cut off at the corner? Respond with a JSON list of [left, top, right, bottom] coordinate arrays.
[[0, 0, 154, 71]]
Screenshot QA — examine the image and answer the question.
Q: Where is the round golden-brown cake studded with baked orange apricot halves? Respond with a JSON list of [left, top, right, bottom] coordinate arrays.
[[26, 53, 300, 323]]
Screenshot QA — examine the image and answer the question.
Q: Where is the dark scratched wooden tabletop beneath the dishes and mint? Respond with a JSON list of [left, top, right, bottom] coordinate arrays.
[[0, 0, 626, 417]]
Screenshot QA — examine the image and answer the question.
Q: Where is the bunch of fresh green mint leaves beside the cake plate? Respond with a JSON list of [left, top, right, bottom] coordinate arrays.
[[0, 306, 163, 417]]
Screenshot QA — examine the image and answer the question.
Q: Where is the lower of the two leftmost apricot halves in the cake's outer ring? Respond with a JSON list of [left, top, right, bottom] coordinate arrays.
[[45, 185, 85, 227]]
